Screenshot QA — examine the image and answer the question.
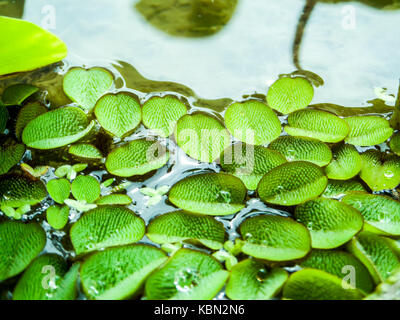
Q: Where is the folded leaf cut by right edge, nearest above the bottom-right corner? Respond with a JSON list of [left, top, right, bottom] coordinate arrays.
[[347, 232, 400, 284]]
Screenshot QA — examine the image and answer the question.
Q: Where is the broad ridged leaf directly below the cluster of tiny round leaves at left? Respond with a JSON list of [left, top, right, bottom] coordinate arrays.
[[70, 206, 145, 254]]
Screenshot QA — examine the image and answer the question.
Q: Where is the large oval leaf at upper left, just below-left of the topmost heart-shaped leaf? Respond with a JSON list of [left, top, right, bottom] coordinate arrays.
[[22, 107, 94, 149]]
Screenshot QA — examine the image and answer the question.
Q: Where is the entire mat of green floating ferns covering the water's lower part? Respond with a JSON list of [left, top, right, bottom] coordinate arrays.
[[0, 62, 400, 300]]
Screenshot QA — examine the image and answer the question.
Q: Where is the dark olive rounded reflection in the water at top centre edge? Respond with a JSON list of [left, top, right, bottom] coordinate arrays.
[[135, 0, 237, 37]]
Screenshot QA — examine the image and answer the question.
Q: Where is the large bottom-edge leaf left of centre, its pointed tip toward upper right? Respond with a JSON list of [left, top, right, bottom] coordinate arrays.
[[81, 244, 167, 300]]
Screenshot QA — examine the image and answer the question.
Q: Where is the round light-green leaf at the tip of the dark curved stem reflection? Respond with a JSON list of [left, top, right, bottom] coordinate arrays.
[[267, 77, 314, 114]]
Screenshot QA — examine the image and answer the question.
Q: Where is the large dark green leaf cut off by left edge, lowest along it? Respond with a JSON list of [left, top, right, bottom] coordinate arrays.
[[0, 221, 46, 281]]
